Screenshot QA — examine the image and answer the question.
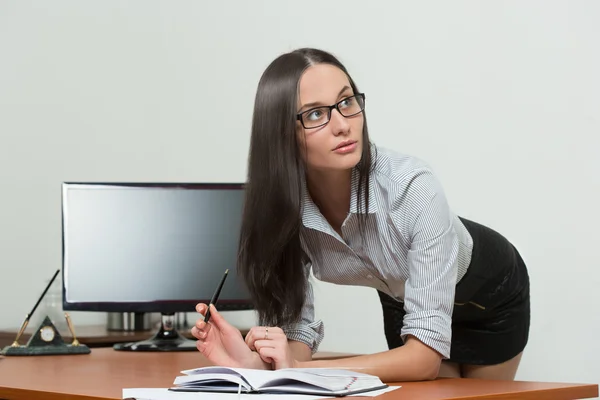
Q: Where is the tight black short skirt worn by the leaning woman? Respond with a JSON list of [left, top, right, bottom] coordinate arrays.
[[378, 218, 530, 365]]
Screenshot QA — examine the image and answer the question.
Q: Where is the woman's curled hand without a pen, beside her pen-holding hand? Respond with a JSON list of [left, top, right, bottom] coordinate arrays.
[[246, 326, 299, 369]]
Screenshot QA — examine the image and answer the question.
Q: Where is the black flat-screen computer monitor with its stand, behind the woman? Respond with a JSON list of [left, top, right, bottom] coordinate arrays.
[[62, 182, 253, 351]]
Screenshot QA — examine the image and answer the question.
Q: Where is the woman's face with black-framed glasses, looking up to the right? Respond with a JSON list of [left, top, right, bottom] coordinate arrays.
[[296, 64, 364, 170]]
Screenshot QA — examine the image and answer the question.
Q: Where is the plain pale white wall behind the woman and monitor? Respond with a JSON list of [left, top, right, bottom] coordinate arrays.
[[0, 0, 600, 383]]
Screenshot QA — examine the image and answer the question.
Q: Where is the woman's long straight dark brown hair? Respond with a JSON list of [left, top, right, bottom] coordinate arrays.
[[238, 48, 372, 326]]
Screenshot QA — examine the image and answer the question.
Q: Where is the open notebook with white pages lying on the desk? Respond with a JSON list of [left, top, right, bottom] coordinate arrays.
[[169, 367, 387, 396]]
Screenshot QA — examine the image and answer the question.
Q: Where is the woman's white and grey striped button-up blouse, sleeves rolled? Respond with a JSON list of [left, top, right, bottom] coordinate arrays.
[[283, 145, 473, 358]]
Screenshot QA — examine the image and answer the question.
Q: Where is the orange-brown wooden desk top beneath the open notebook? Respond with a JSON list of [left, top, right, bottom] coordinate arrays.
[[0, 348, 598, 400]]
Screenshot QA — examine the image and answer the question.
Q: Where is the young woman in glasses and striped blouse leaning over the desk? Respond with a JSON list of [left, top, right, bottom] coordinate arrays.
[[192, 49, 530, 381]]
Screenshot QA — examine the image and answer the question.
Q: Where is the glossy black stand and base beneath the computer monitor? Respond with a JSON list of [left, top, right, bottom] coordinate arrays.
[[113, 314, 197, 351]]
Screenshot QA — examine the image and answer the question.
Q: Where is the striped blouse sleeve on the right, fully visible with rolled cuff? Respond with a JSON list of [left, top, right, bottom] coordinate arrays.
[[393, 168, 459, 358]]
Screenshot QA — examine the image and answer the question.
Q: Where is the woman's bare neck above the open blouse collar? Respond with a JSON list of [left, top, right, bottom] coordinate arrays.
[[307, 170, 352, 234]]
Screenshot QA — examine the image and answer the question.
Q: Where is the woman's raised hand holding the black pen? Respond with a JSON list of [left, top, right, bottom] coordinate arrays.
[[192, 304, 271, 369]]
